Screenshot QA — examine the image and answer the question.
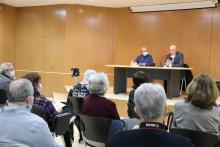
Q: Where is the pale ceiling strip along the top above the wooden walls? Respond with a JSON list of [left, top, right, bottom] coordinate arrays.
[[0, 0, 214, 8]]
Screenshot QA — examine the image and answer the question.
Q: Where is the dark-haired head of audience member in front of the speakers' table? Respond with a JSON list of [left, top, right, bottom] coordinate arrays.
[[133, 71, 149, 89]]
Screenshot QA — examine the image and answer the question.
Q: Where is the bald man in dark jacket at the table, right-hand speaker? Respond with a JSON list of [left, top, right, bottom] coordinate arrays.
[[164, 45, 184, 67]]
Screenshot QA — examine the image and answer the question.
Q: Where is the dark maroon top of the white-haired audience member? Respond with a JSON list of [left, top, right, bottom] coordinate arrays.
[[82, 95, 120, 119]]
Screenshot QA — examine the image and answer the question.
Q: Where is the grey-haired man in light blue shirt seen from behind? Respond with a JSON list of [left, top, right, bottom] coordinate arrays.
[[0, 79, 58, 147]]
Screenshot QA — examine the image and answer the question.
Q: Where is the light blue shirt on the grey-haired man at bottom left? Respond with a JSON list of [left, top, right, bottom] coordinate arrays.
[[0, 106, 58, 147]]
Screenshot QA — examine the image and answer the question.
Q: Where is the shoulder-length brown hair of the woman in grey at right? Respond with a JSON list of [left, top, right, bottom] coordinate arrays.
[[186, 75, 219, 109]]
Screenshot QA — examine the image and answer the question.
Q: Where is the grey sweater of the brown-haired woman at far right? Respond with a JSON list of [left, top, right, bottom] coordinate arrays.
[[174, 102, 220, 134]]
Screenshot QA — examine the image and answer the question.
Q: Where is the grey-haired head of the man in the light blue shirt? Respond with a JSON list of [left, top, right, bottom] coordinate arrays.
[[9, 79, 34, 101]]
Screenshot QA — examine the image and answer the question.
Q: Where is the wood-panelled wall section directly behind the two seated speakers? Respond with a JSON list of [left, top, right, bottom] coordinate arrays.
[[114, 5, 220, 79]]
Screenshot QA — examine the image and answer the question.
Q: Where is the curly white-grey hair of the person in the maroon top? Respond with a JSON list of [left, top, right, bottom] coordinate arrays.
[[88, 72, 109, 96]]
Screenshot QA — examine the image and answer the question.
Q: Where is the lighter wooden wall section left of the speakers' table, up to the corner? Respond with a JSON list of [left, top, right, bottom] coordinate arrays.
[[16, 5, 115, 96]]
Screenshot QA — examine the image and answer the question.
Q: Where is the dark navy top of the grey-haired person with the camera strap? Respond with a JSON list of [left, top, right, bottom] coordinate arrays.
[[106, 129, 194, 147]]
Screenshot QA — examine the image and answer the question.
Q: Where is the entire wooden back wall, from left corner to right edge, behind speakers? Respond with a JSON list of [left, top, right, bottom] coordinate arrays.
[[16, 5, 220, 95]]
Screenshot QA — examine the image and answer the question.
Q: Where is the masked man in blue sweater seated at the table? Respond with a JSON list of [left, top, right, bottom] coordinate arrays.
[[135, 47, 153, 66]]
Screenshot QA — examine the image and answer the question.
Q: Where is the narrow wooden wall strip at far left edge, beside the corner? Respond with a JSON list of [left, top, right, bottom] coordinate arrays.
[[0, 4, 16, 63]]
